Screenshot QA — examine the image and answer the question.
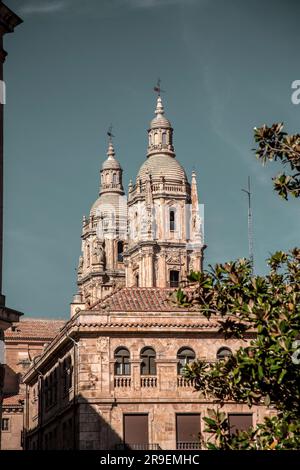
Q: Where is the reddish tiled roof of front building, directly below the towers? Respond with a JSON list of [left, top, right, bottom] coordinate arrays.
[[90, 287, 188, 312]]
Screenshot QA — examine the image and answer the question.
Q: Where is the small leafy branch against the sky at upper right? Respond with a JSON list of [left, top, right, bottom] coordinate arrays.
[[254, 123, 300, 199]]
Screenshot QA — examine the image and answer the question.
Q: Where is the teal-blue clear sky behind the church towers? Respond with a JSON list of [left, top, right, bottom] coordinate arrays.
[[4, 0, 300, 318]]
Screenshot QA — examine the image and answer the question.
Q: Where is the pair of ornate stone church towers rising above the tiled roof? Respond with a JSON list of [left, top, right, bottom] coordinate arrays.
[[74, 96, 203, 309]]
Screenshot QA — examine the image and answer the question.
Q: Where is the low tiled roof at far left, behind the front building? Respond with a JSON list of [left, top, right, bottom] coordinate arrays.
[[5, 317, 66, 340]]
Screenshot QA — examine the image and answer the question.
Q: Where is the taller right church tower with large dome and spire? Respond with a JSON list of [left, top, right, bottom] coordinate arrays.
[[124, 94, 203, 287]]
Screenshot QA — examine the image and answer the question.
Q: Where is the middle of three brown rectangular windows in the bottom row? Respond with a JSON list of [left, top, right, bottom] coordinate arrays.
[[176, 413, 200, 450]]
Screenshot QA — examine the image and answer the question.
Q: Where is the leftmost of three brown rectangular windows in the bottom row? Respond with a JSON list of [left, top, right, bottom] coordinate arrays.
[[124, 414, 149, 450]]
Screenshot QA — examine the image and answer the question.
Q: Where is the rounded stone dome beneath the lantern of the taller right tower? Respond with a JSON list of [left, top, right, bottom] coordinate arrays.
[[137, 154, 187, 182]]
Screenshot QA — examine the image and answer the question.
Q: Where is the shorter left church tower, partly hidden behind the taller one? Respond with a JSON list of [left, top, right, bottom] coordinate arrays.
[[71, 137, 127, 315]]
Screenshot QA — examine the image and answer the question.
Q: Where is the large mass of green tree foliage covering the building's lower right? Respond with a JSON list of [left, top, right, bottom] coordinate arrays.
[[177, 248, 300, 449]]
